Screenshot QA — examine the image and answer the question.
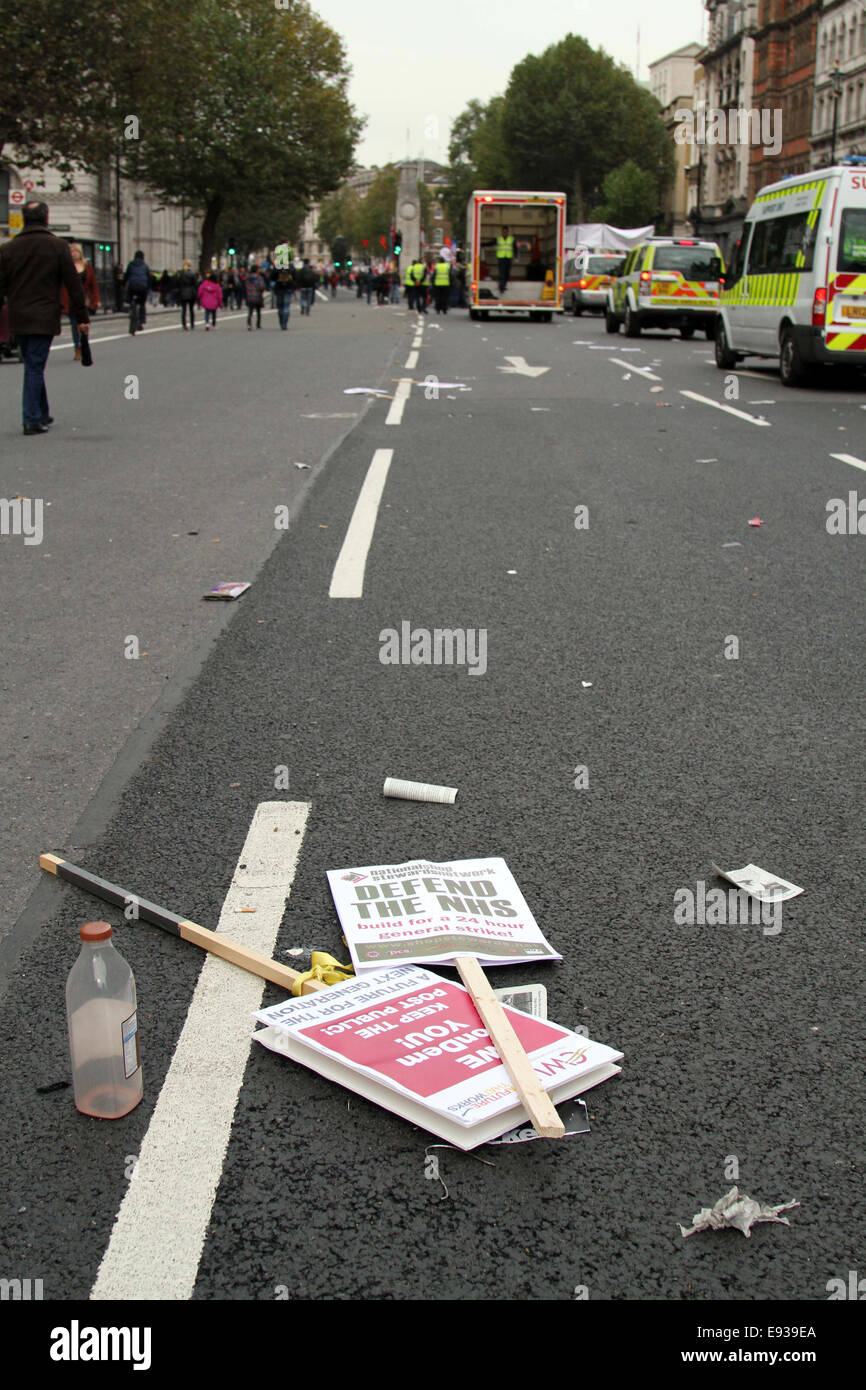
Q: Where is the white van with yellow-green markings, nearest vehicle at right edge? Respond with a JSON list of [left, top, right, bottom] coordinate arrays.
[[716, 154, 866, 386]]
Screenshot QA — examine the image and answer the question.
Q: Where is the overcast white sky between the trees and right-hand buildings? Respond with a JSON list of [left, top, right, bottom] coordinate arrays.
[[311, 0, 706, 165]]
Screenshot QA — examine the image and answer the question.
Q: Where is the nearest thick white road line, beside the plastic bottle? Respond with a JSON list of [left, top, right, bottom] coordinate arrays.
[[90, 801, 310, 1301]]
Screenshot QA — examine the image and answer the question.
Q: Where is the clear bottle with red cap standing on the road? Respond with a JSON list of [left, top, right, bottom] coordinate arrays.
[[67, 922, 142, 1120]]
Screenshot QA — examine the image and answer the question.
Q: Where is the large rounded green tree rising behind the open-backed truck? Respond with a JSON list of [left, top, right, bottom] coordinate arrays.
[[502, 35, 673, 221]]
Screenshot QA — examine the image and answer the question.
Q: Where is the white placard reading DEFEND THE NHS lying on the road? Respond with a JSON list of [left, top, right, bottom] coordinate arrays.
[[328, 859, 562, 973]]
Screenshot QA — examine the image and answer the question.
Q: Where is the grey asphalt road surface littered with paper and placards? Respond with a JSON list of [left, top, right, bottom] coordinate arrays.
[[0, 297, 866, 1323]]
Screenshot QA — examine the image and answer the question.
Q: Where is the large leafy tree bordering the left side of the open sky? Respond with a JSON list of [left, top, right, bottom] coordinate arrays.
[[124, 0, 361, 268]]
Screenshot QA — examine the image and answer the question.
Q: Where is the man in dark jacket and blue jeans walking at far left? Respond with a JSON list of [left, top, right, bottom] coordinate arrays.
[[0, 202, 90, 435]]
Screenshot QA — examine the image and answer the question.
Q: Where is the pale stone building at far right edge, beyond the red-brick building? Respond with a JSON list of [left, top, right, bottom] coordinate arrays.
[[812, 0, 866, 165]]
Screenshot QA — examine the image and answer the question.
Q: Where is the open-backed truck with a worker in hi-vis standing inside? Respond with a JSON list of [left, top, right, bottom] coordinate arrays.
[[466, 188, 566, 324]]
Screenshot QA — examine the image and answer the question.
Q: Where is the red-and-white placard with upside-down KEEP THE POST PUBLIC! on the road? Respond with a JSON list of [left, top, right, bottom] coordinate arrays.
[[254, 965, 623, 1150]]
